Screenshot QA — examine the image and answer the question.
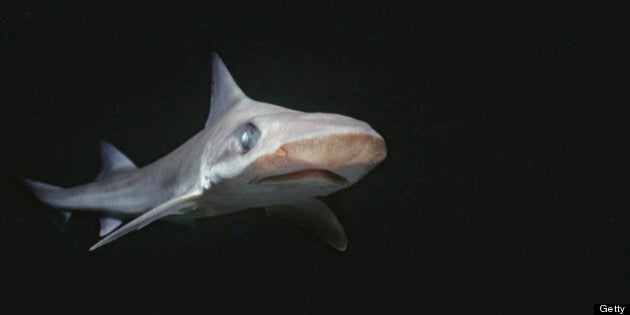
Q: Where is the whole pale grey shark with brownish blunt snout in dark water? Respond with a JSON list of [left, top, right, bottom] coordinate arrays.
[[23, 53, 387, 251]]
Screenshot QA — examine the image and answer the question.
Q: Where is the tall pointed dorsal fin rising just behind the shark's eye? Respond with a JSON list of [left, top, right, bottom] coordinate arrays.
[[206, 53, 246, 127]]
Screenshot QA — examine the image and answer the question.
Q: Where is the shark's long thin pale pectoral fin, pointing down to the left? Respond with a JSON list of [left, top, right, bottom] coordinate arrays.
[[90, 191, 201, 251]]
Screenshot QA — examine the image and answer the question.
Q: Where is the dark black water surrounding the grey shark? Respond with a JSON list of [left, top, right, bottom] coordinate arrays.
[[0, 1, 630, 314]]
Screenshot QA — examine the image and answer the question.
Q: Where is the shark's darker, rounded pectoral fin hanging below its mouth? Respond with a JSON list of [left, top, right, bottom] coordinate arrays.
[[265, 199, 348, 251]]
